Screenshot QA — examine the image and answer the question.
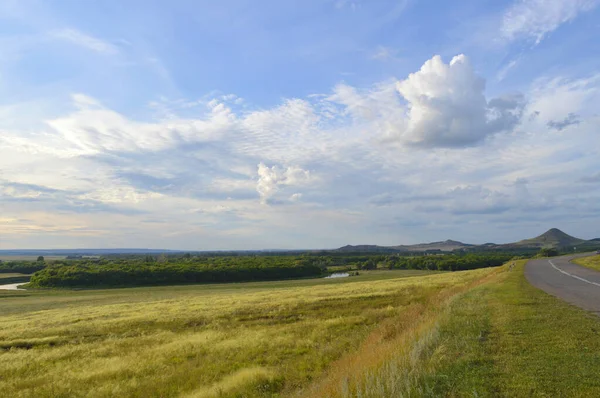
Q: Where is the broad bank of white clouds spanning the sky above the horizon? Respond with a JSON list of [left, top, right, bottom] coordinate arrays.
[[0, 52, 600, 249]]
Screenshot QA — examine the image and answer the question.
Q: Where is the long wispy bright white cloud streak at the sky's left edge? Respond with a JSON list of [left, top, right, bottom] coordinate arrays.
[[0, 94, 235, 157]]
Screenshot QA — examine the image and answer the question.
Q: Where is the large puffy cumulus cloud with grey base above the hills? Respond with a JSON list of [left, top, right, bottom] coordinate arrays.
[[390, 55, 521, 147]]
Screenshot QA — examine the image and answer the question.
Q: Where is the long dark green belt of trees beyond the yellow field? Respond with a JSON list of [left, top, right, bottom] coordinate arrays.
[[21, 253, 513, 288]]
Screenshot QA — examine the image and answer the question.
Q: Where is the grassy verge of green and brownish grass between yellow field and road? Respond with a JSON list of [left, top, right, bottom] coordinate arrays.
[[312, 261, 600, 397]]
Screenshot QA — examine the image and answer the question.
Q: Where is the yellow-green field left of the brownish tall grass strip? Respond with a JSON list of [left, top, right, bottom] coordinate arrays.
[[0, 269, 492, 397]]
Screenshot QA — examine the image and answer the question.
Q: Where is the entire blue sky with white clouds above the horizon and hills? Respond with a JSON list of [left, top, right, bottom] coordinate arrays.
[[0, 0, 600, 250]]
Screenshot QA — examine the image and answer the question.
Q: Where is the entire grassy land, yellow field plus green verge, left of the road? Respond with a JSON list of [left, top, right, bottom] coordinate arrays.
[[0, 261, 600, 398]]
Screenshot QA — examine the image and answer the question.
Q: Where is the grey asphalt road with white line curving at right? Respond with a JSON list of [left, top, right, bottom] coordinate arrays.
[[525, 254, 600, 315]]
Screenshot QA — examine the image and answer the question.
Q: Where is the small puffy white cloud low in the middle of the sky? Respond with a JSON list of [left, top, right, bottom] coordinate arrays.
[[256, 162, 311, 204]]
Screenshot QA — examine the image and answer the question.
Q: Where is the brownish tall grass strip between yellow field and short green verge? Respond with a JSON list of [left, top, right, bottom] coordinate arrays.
[[301, 269, 501, 398]]
